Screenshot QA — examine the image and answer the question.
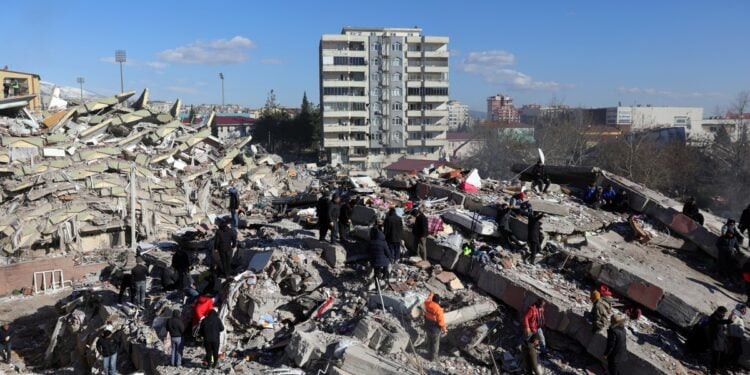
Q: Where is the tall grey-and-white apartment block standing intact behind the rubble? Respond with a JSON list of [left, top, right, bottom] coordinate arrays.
[[320, 27, 448, 170]]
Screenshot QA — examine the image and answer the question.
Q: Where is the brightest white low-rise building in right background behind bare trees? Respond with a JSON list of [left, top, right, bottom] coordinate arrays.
[[606, 106, 706, 138]]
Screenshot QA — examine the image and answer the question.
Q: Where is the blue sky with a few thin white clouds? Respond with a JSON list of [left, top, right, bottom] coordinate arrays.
[[0, 0, 750, 114]]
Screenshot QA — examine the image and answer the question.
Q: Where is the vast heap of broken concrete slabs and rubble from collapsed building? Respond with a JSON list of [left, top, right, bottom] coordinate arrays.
[[0, 91, 750, 374]]
